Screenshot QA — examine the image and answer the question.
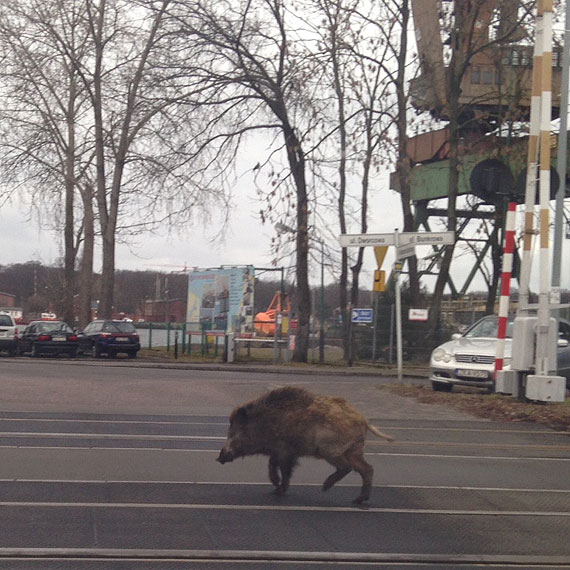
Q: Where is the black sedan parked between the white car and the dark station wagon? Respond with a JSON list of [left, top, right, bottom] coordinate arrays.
[[18, 321, 79, 358]]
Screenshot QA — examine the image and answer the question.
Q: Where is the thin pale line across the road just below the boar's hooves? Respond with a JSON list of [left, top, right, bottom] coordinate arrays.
[[0, 501, 570, 518]]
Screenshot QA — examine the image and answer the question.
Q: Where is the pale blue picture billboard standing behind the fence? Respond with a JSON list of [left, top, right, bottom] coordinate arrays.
[[186, 265, 254, 333]]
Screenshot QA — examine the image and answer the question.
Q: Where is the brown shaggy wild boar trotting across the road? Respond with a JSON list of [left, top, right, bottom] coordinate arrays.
[[217, 387, 392, 503]]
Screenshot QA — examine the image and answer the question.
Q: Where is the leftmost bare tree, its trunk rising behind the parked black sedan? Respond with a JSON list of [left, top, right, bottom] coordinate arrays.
[[0, 0, 93, 322]]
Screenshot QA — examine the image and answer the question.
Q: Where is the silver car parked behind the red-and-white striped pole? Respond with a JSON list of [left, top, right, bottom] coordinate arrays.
[[430, 315, 570, 392]]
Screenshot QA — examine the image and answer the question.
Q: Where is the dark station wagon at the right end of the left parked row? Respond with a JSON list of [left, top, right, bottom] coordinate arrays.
[[78, 320, 141, 358]]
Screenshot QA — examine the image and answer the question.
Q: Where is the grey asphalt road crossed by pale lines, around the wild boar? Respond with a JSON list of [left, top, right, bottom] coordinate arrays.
[[0, 358, 570, 570]]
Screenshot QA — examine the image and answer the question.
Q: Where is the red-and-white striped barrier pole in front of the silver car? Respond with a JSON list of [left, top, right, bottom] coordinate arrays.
[[494, 202, 517, 381]]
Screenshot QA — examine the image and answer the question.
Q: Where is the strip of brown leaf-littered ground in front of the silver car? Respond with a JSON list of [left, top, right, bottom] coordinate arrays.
[[378, 384, 570, 433]]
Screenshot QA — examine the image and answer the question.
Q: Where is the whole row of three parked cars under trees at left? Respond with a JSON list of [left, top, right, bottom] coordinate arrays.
[[0, 313, 140, 358]]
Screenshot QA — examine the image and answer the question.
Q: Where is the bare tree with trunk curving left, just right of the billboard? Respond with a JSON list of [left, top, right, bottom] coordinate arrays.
[[169, 0, 320, 361]]
